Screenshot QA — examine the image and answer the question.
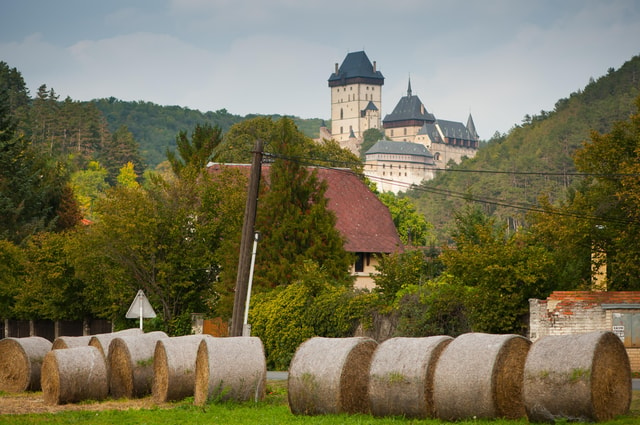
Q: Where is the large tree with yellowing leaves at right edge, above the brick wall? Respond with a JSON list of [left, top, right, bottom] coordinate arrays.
[[529, 97, 640, 290]]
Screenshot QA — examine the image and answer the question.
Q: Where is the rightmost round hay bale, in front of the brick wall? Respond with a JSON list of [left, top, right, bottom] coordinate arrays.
[[523, 332, 632, 422]]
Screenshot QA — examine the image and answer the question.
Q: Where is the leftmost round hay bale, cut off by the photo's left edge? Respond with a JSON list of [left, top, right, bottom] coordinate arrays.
[[0, 336, 51, 392]]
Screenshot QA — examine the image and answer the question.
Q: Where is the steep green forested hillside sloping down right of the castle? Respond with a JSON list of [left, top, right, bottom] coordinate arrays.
[[408, 56, 640, 238]]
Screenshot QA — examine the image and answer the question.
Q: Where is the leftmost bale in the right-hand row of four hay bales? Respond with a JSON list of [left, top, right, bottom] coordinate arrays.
[[288, 337, 378, 415]]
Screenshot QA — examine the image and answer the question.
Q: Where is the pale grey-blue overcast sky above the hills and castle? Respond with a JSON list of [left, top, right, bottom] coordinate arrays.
[[0, 0, 640, 140]]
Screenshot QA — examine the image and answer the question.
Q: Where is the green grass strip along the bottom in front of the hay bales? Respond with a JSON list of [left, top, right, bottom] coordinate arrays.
[[0, 381, 640, 425]]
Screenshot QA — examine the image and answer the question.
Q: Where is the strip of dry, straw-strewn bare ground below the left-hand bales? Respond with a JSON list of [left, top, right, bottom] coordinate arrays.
[[0, 392, 175, 415]]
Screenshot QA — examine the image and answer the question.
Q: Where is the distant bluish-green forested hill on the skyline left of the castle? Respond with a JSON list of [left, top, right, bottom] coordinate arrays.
[[92, 97, 322, 168]]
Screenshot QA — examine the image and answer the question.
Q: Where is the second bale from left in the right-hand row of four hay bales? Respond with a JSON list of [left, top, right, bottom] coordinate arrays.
[[369, 336, 453, 418]]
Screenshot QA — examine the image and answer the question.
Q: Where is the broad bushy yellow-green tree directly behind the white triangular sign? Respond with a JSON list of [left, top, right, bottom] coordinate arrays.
[[78, 173, 223, 333]]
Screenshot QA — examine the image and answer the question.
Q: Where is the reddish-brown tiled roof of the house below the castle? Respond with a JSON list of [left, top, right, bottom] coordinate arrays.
[[209, 164, 403, 253]]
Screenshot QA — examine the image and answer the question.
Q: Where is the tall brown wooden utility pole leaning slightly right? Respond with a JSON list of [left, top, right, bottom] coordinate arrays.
[[230, 139, 263, 336]]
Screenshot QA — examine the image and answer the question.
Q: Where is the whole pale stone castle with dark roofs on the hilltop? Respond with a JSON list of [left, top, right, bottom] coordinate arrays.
[[320, 51, 479, 193]]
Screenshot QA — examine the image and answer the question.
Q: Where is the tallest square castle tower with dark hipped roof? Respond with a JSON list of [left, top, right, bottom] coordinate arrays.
[[329, 52, 384, 144]]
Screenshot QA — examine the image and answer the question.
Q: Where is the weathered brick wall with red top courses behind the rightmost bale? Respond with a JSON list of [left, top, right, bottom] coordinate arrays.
[[529, 291, 640, 372]]
